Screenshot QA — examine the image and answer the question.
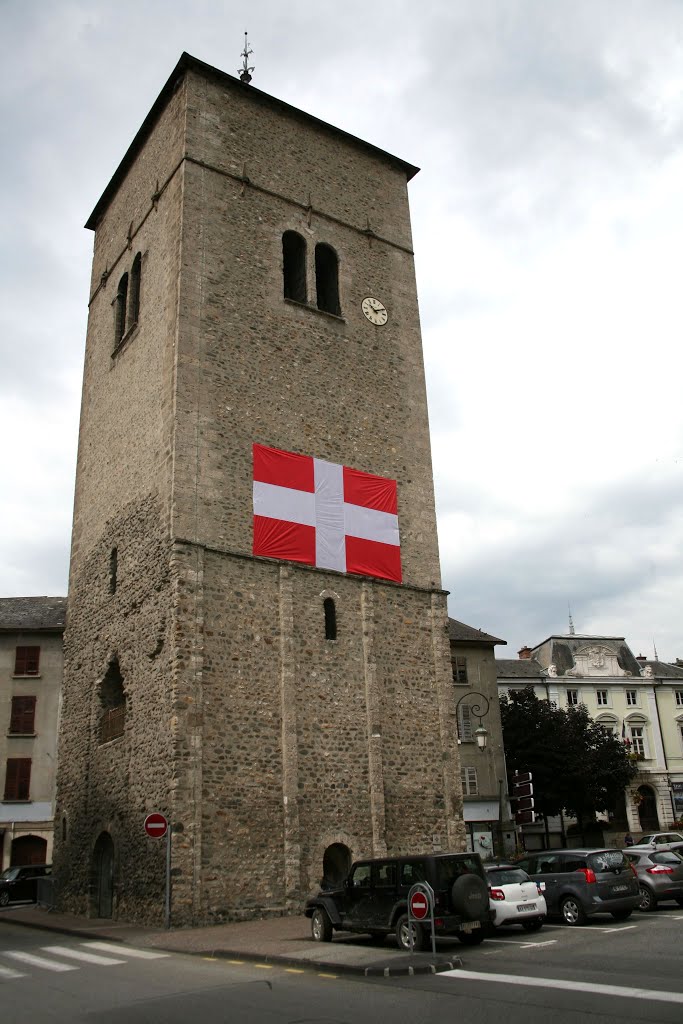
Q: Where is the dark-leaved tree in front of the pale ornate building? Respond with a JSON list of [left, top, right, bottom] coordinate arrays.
[[501, 687, 638, 828]]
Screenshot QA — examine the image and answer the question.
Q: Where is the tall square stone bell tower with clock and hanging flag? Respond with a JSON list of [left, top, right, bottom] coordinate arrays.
[[55, 54, 464, 924]]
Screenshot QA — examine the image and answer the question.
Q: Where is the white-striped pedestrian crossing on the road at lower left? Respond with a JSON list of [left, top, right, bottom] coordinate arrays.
[[0, 942, 169, 982]]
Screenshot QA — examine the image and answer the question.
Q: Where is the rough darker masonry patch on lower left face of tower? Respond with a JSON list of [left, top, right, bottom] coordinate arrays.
[[55, 499, 173, 922]]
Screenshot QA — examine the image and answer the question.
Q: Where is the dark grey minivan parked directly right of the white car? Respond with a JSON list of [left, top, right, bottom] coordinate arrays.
[[518, 849, 640, 925]]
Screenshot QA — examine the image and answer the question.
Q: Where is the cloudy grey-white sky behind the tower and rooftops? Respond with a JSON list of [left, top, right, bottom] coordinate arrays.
[[0, 0, 683, 660]]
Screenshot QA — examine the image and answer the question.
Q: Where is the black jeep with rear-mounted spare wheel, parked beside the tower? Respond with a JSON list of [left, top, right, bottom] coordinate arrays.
[[304, 853, 492, 949]]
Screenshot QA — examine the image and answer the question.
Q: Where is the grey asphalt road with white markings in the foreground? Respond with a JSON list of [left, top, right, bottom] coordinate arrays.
[[0, 908, 683, 1024]]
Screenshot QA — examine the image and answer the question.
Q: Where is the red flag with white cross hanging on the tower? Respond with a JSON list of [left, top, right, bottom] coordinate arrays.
[[254, 444, 401, 583]]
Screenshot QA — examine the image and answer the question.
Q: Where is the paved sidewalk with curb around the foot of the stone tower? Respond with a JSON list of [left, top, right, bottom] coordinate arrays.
[[0, 904, 462, 977]]
